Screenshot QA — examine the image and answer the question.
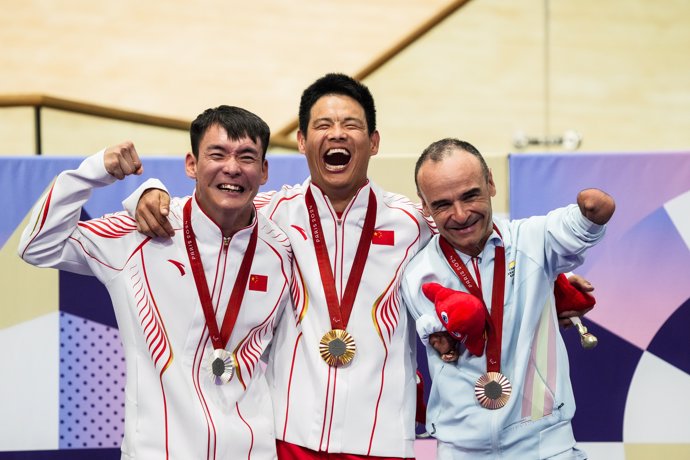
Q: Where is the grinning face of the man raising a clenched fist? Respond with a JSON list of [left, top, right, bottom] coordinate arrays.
[[185, 124, 268, 236]]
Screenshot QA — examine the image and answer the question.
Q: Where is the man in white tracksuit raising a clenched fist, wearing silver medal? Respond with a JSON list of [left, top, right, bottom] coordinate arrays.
[[20, 106, 292, 460]]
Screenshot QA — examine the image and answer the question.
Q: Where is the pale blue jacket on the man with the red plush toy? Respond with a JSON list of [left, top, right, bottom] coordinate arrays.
[[402, 205, 605, 460]]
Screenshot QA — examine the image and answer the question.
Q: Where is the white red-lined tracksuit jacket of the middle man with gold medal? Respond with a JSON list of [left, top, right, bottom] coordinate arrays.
[[255, 179, 432, 457]]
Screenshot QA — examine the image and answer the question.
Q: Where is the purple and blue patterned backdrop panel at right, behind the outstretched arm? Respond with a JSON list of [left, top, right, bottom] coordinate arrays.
[[510, 152, 690, 444]]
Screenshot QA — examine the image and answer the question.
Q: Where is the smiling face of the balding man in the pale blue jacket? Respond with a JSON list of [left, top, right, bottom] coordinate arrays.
[[417, 149, 496, 256]]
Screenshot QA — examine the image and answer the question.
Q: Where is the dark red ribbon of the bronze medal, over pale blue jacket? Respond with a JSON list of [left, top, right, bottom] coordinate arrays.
[[439, 225, 506, 372]]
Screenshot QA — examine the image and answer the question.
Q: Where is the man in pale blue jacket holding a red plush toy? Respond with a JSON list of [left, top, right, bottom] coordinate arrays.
[[401, 139, 615, 460]]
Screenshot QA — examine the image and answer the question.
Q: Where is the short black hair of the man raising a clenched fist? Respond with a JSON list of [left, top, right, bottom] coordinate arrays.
[[194, 105, 271, 161]]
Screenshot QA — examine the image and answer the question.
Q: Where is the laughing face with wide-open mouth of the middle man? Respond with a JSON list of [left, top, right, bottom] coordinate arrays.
[[297, 94, 379, 211]]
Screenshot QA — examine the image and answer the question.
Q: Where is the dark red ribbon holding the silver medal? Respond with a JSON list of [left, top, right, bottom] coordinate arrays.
[[182, 198, 259, 349]]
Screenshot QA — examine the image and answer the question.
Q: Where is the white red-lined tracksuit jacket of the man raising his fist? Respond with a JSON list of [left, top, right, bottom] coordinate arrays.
[[19, 151, 292, 460]]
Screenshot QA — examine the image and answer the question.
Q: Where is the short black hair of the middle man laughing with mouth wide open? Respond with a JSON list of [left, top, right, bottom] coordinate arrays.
[[299, 73, 376, 136]]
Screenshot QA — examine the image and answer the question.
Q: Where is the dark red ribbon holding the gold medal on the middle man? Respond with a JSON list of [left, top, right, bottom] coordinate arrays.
[[304, 188, 376, 330]]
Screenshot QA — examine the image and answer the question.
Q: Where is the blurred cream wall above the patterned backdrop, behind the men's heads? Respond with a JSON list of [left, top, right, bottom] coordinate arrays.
[[0, 0, 690, 212]]
